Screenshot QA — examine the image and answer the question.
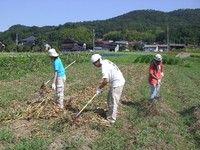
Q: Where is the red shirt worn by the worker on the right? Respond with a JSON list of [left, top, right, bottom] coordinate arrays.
[[149, 60, 163, 84]]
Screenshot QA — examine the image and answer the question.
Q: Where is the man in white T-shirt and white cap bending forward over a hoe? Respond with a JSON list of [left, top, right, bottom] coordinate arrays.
[[91, 54, 125, 123]]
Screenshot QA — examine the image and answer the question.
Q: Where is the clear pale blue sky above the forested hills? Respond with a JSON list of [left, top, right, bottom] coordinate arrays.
[[0, 0, 200, 32]]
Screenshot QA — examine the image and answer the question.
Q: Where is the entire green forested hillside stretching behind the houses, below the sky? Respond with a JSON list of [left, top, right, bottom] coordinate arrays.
[[0, 9, 200, 48]]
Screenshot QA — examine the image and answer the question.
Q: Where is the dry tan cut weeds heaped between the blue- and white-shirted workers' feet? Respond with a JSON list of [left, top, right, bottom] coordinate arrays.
[[1, 81, 107, 131]]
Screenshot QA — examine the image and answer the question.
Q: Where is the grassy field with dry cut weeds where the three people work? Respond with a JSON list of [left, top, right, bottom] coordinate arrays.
[[0, 52, 200, 150]]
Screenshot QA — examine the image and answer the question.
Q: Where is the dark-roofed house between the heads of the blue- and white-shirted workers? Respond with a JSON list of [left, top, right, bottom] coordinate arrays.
[[61, 39, 86, 52]]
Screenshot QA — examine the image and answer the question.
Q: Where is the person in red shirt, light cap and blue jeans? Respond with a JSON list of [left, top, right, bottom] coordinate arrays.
[[149, 54, 164, 101]]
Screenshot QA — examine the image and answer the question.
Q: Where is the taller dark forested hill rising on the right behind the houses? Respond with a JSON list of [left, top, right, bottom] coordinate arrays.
[[77, 9, 200, 43]]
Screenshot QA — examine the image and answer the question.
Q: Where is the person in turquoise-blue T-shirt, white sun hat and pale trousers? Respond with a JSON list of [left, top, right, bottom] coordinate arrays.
[[48, 48, 66, 109]]
